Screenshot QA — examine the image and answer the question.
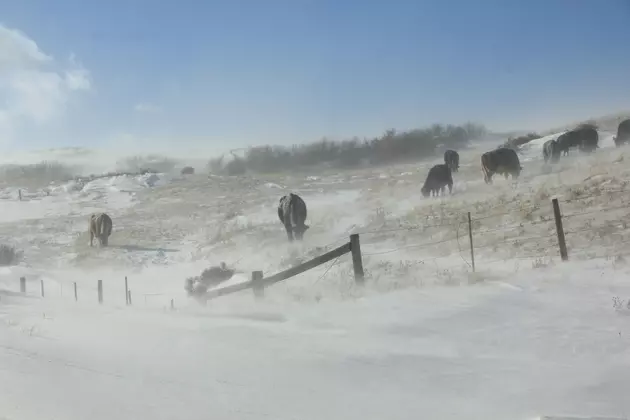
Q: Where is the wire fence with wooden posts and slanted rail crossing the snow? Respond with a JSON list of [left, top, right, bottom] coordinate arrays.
[[12, 190, 630, 310]]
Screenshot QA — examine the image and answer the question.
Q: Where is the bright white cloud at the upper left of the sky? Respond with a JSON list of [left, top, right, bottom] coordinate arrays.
[[0, 24, 92, 141]]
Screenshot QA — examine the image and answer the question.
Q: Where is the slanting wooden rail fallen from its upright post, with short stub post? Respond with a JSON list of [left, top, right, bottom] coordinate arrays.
[[201, 234, 364, 300]]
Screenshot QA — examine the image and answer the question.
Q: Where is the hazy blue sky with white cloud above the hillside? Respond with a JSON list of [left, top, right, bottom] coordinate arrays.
[[0, 0, 630, 154]]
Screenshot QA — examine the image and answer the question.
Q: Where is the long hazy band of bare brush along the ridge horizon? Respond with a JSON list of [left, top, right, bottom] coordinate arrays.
[[208, 123, 487, 175]]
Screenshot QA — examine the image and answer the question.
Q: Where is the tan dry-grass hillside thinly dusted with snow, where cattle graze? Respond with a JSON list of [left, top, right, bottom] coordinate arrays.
[[0, 130, 630, 301]]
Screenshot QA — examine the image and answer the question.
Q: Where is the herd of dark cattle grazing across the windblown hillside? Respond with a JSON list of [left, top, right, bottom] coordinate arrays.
[[89, 119, 630, 251]]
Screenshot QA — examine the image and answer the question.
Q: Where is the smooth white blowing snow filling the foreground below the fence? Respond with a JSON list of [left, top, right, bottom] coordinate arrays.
[[0, 262, 630, 420]]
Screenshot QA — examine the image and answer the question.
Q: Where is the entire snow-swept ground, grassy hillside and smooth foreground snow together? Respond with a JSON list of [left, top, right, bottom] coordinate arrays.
[[0, 133, 630, 420]]
